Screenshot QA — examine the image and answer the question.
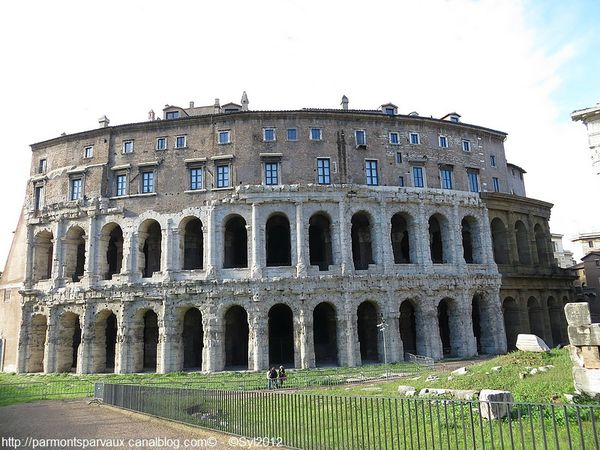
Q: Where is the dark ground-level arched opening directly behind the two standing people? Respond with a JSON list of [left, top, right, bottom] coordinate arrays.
[[269, 303, 294, 365]]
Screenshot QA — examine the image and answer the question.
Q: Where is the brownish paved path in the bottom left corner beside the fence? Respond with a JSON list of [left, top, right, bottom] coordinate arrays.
[[0, 399, 260, 450]]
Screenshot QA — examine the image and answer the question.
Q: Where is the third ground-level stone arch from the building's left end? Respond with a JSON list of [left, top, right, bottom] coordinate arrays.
[[92, 309, 117, 373]]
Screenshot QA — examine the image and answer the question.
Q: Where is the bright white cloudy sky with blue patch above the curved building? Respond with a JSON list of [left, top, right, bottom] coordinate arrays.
[[0, 0, 600, 267]]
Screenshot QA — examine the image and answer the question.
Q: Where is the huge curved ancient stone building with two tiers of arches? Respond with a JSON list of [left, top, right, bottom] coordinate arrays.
[[0, 95, 572, 373]]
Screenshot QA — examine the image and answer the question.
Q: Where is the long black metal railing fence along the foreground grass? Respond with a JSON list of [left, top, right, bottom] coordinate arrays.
[[102, 384, 600, 450]]
